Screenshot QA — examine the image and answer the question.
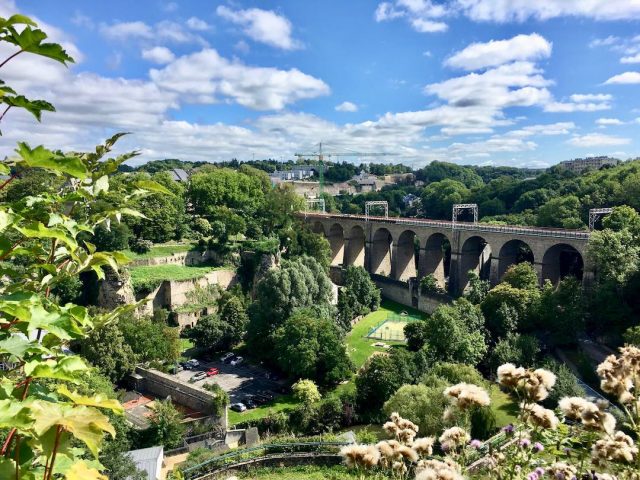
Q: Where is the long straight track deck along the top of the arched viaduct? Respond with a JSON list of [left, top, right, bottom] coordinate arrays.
[[304, 212, 591, 240]]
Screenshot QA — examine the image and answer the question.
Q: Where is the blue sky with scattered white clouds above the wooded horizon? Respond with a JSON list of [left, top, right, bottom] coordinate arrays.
[[0, 0, 640, 167]]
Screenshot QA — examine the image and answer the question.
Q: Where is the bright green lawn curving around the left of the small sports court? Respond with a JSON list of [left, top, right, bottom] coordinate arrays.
[[346, 300, 424, 368]]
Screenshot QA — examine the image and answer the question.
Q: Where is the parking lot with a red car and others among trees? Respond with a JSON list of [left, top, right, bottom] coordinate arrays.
[[177, 361, 284, 403]]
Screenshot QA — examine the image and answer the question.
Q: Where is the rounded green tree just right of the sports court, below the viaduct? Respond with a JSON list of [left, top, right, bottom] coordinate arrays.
[[424, 298, 487, 365]]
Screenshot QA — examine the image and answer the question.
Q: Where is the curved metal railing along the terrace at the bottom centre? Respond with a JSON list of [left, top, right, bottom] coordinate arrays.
[[182, 442, 350, 480]]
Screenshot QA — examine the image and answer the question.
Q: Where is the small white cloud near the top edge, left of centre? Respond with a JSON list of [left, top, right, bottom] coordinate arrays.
[[216, 5, 301, 50]]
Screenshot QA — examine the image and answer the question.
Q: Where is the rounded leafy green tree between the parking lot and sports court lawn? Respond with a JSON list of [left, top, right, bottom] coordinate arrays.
[[272, 309, 352, 385]]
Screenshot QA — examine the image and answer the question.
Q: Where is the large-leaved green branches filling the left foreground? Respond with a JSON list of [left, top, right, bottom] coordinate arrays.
[[0, 15, 172, 480]]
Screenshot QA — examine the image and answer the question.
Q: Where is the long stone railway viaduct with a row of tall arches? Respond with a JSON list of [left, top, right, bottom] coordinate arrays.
[[305, 213, 593, 295]]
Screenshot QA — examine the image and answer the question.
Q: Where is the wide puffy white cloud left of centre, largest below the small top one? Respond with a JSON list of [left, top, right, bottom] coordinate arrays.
[[149, 49, 330, 110]]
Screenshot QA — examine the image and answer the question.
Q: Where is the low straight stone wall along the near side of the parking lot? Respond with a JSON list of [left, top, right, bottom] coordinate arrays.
[[136, 367, 227, 429]]
